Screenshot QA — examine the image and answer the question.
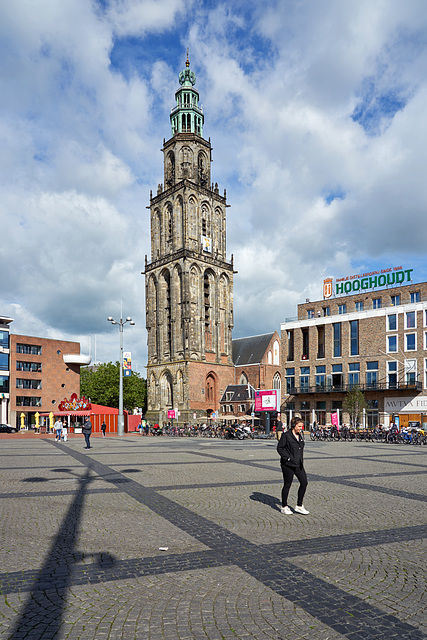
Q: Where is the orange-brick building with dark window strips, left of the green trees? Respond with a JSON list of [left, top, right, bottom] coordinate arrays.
[[9, 334, 90, 427]]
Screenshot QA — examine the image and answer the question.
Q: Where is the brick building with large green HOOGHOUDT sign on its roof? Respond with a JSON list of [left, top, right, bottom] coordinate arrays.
[[281, 270, 427, 427]]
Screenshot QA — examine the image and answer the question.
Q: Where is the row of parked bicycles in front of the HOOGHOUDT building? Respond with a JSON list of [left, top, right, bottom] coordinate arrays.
[[310, 426, 427, 445]]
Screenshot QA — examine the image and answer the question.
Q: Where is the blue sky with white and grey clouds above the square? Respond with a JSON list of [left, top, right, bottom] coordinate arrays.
[[0, 0, 427, 375]]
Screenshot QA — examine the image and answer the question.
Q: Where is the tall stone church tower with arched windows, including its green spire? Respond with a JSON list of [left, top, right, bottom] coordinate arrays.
[[144, 56, 234, 424]]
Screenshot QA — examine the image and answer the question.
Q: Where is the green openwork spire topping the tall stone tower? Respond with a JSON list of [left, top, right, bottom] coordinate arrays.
[[170, 49, 204, 136]]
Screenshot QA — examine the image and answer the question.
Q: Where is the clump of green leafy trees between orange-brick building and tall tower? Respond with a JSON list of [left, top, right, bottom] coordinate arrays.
[[80, 362, 147, 413]]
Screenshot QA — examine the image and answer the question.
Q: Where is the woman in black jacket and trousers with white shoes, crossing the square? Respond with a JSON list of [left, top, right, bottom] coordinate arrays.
[[277, 418, 309, 516]]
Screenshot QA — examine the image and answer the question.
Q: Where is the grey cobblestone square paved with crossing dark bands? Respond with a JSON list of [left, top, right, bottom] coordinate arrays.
[[0, 435, 427, 640]]
